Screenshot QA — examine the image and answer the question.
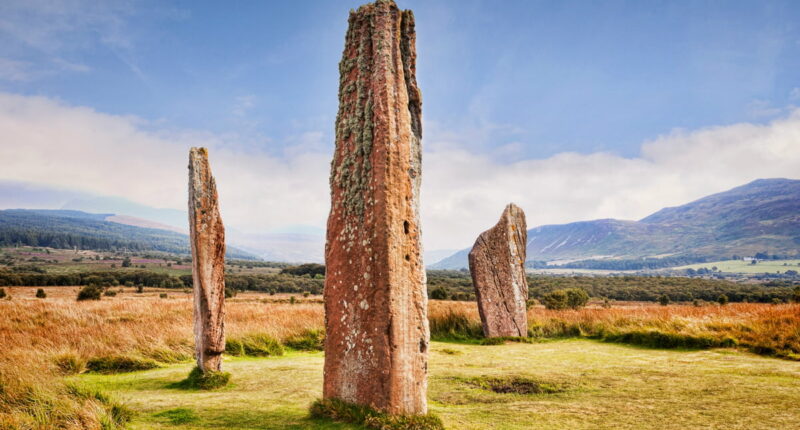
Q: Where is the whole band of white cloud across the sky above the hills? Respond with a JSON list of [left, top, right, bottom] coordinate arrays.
[[0, 90, 800, 250]]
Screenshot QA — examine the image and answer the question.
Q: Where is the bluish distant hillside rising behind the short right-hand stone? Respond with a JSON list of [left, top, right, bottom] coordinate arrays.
[[432, 179, 800, 269]]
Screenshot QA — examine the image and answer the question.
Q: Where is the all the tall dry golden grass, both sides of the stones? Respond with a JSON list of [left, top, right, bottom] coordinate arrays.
[[0, 287, 800, 429]]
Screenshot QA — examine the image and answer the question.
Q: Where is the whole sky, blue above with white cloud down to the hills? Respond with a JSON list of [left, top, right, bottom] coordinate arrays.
[[0, 0, 800, 254]]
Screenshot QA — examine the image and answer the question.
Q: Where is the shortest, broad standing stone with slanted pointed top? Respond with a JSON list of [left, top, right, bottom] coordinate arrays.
[[469, 203, 528, 337]]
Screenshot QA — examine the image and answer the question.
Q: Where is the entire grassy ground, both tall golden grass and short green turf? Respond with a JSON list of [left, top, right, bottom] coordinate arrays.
[[0, 287, 800, 429]]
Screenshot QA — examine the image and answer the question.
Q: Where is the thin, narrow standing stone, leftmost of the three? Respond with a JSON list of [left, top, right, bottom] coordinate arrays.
[[189, 148, 225, 373]]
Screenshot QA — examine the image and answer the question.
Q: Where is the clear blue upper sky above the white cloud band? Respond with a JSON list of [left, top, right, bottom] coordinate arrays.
[[0, 1, 800, 157]]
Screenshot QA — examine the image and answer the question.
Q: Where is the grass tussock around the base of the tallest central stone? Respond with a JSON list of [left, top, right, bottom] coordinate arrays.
[[310, 399, 444, 430]]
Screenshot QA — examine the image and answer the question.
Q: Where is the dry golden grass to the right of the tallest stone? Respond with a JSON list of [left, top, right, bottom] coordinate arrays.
[[429, 302, 800, 359]]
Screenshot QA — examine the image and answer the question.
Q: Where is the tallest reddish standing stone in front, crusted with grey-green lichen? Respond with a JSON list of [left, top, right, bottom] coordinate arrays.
[[323, 0, 430, 414]]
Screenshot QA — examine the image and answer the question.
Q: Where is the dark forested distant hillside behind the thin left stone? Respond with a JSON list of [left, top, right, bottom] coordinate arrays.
[[0, 209, 254, 259]]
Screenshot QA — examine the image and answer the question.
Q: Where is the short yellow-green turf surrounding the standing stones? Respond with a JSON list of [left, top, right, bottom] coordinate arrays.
[[76, 340, 800, 430]]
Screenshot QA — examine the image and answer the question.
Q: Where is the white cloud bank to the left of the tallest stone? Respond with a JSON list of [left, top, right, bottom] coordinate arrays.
[[0, 94, 330, 237]]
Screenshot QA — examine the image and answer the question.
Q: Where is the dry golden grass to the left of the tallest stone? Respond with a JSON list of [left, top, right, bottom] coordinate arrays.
[[0, 287, 324, 429]]
